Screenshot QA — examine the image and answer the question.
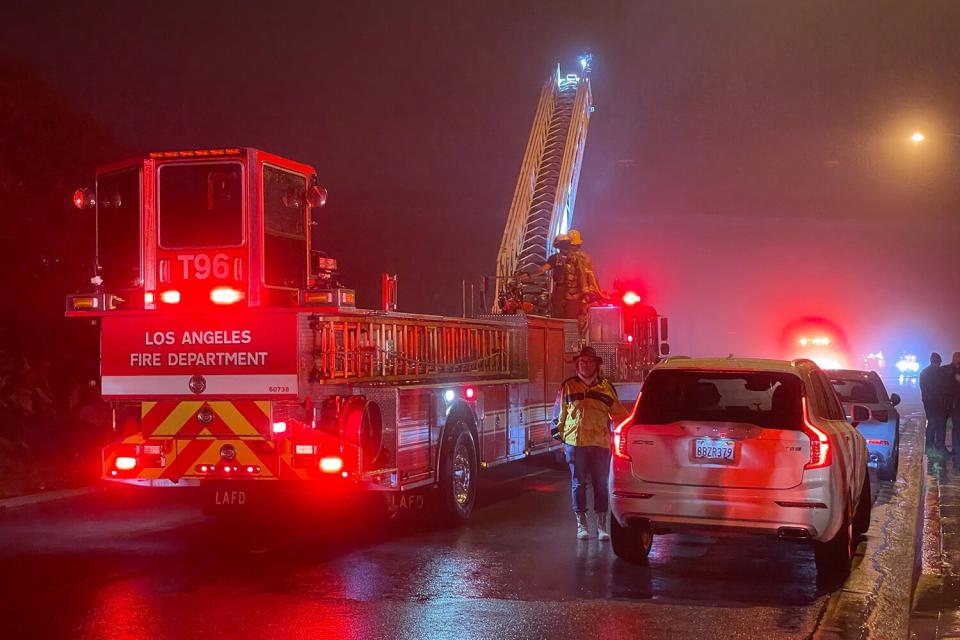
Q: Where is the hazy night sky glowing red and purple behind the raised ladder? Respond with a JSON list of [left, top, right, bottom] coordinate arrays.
[[0, 0, 960, 359]]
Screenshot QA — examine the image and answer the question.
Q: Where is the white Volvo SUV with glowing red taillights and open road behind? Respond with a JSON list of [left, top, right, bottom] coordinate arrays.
[[610, 358, 870, 574]]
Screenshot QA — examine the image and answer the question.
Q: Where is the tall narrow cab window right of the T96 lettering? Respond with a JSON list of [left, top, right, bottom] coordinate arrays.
[[263, 164, 307, 289]]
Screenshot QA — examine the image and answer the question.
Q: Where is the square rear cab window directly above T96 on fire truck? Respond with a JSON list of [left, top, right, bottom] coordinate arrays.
[[158, 162, 243, 249]]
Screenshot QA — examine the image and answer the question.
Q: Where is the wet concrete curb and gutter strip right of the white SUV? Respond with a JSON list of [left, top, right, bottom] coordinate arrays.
[[813, 416, 927, 640]]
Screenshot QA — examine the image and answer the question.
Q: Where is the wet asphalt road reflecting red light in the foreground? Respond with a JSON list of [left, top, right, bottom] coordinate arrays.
[[0, 378, 924, 640]]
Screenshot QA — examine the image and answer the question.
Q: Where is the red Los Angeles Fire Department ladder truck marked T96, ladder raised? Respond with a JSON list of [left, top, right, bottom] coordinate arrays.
[[67, 58, 660, 521]]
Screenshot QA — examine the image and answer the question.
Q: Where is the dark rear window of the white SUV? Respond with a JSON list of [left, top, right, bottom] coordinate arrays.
[[635, 369, 803, 430]]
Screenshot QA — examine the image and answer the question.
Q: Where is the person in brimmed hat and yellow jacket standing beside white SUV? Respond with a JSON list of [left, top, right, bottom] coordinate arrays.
[[551, 347, 629, 540]]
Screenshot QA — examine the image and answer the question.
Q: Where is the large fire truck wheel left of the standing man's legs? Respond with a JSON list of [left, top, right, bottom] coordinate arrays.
[[440, 422, 477, 524]]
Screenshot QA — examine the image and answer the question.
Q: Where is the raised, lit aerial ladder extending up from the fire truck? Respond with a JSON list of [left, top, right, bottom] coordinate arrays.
[[493, 54, 593, 313]]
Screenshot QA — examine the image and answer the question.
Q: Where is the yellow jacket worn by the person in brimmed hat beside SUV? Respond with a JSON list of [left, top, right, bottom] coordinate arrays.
[[551, 376, 629, 448]]
